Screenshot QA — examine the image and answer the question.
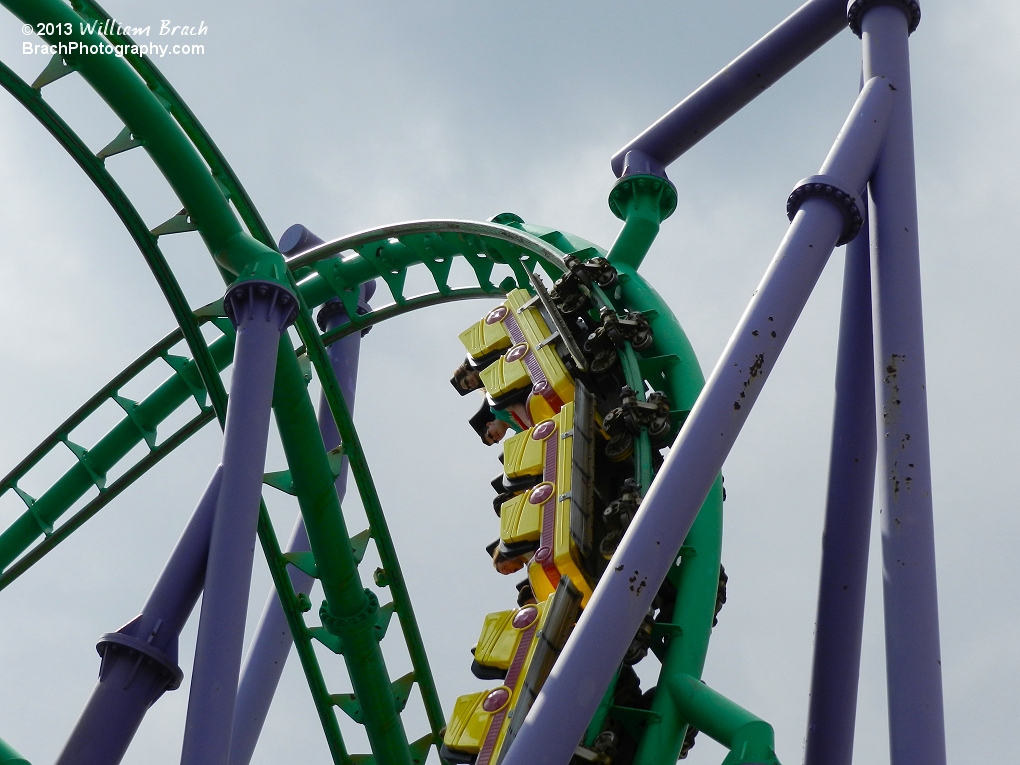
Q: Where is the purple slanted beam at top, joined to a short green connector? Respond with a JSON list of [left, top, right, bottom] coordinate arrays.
[[612, 0, 847, 176]]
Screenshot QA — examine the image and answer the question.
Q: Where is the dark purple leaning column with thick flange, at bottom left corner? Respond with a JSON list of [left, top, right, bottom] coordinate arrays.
[[57, 468, 220, 765]]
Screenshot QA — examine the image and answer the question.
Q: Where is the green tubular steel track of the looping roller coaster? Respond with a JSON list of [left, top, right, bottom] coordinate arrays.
[[0, 0, 770, 765]]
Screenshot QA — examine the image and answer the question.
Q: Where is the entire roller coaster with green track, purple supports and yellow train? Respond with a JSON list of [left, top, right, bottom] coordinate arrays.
[[0, 0, 946, 765]]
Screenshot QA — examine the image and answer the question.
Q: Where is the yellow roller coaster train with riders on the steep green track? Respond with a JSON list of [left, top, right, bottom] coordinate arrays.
[[441, 256, 714, 765]]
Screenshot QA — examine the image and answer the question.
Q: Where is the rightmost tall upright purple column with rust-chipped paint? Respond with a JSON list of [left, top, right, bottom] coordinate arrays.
[[850, 0, 946, 765]]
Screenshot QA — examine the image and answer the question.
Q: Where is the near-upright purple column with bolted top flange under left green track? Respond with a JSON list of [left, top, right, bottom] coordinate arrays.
[[181, 281, 297, 765]]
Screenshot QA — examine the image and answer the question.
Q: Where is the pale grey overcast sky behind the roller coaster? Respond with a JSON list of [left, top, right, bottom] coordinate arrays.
[[0, 0, 1020, 765]]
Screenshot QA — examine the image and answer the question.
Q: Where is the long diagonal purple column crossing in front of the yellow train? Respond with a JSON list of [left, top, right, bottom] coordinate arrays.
[[504, 80, 895, 765]]
